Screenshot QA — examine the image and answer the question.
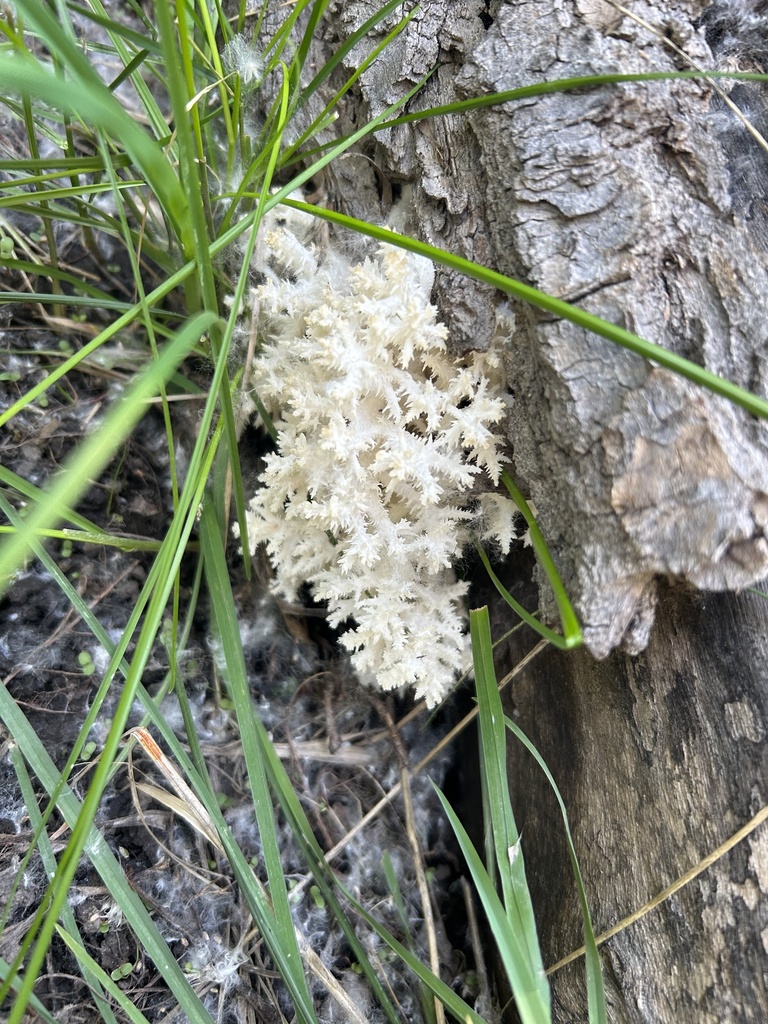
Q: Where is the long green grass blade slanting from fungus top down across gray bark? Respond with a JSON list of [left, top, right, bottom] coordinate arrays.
[[282, 196, 768, 419]]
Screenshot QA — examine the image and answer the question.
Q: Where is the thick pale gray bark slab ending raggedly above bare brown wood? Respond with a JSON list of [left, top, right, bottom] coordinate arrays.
[[461, 3, 768, 656]]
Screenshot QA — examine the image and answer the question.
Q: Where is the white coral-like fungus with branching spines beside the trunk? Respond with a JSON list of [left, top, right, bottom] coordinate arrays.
[[241, 229, 506, 706]]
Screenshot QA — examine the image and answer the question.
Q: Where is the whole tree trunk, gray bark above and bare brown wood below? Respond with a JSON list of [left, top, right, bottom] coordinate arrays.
[[256, 0, 768, 1024]]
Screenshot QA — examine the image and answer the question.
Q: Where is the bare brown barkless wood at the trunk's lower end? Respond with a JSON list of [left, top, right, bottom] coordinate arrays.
[[496, 589, 768, 1024]]
